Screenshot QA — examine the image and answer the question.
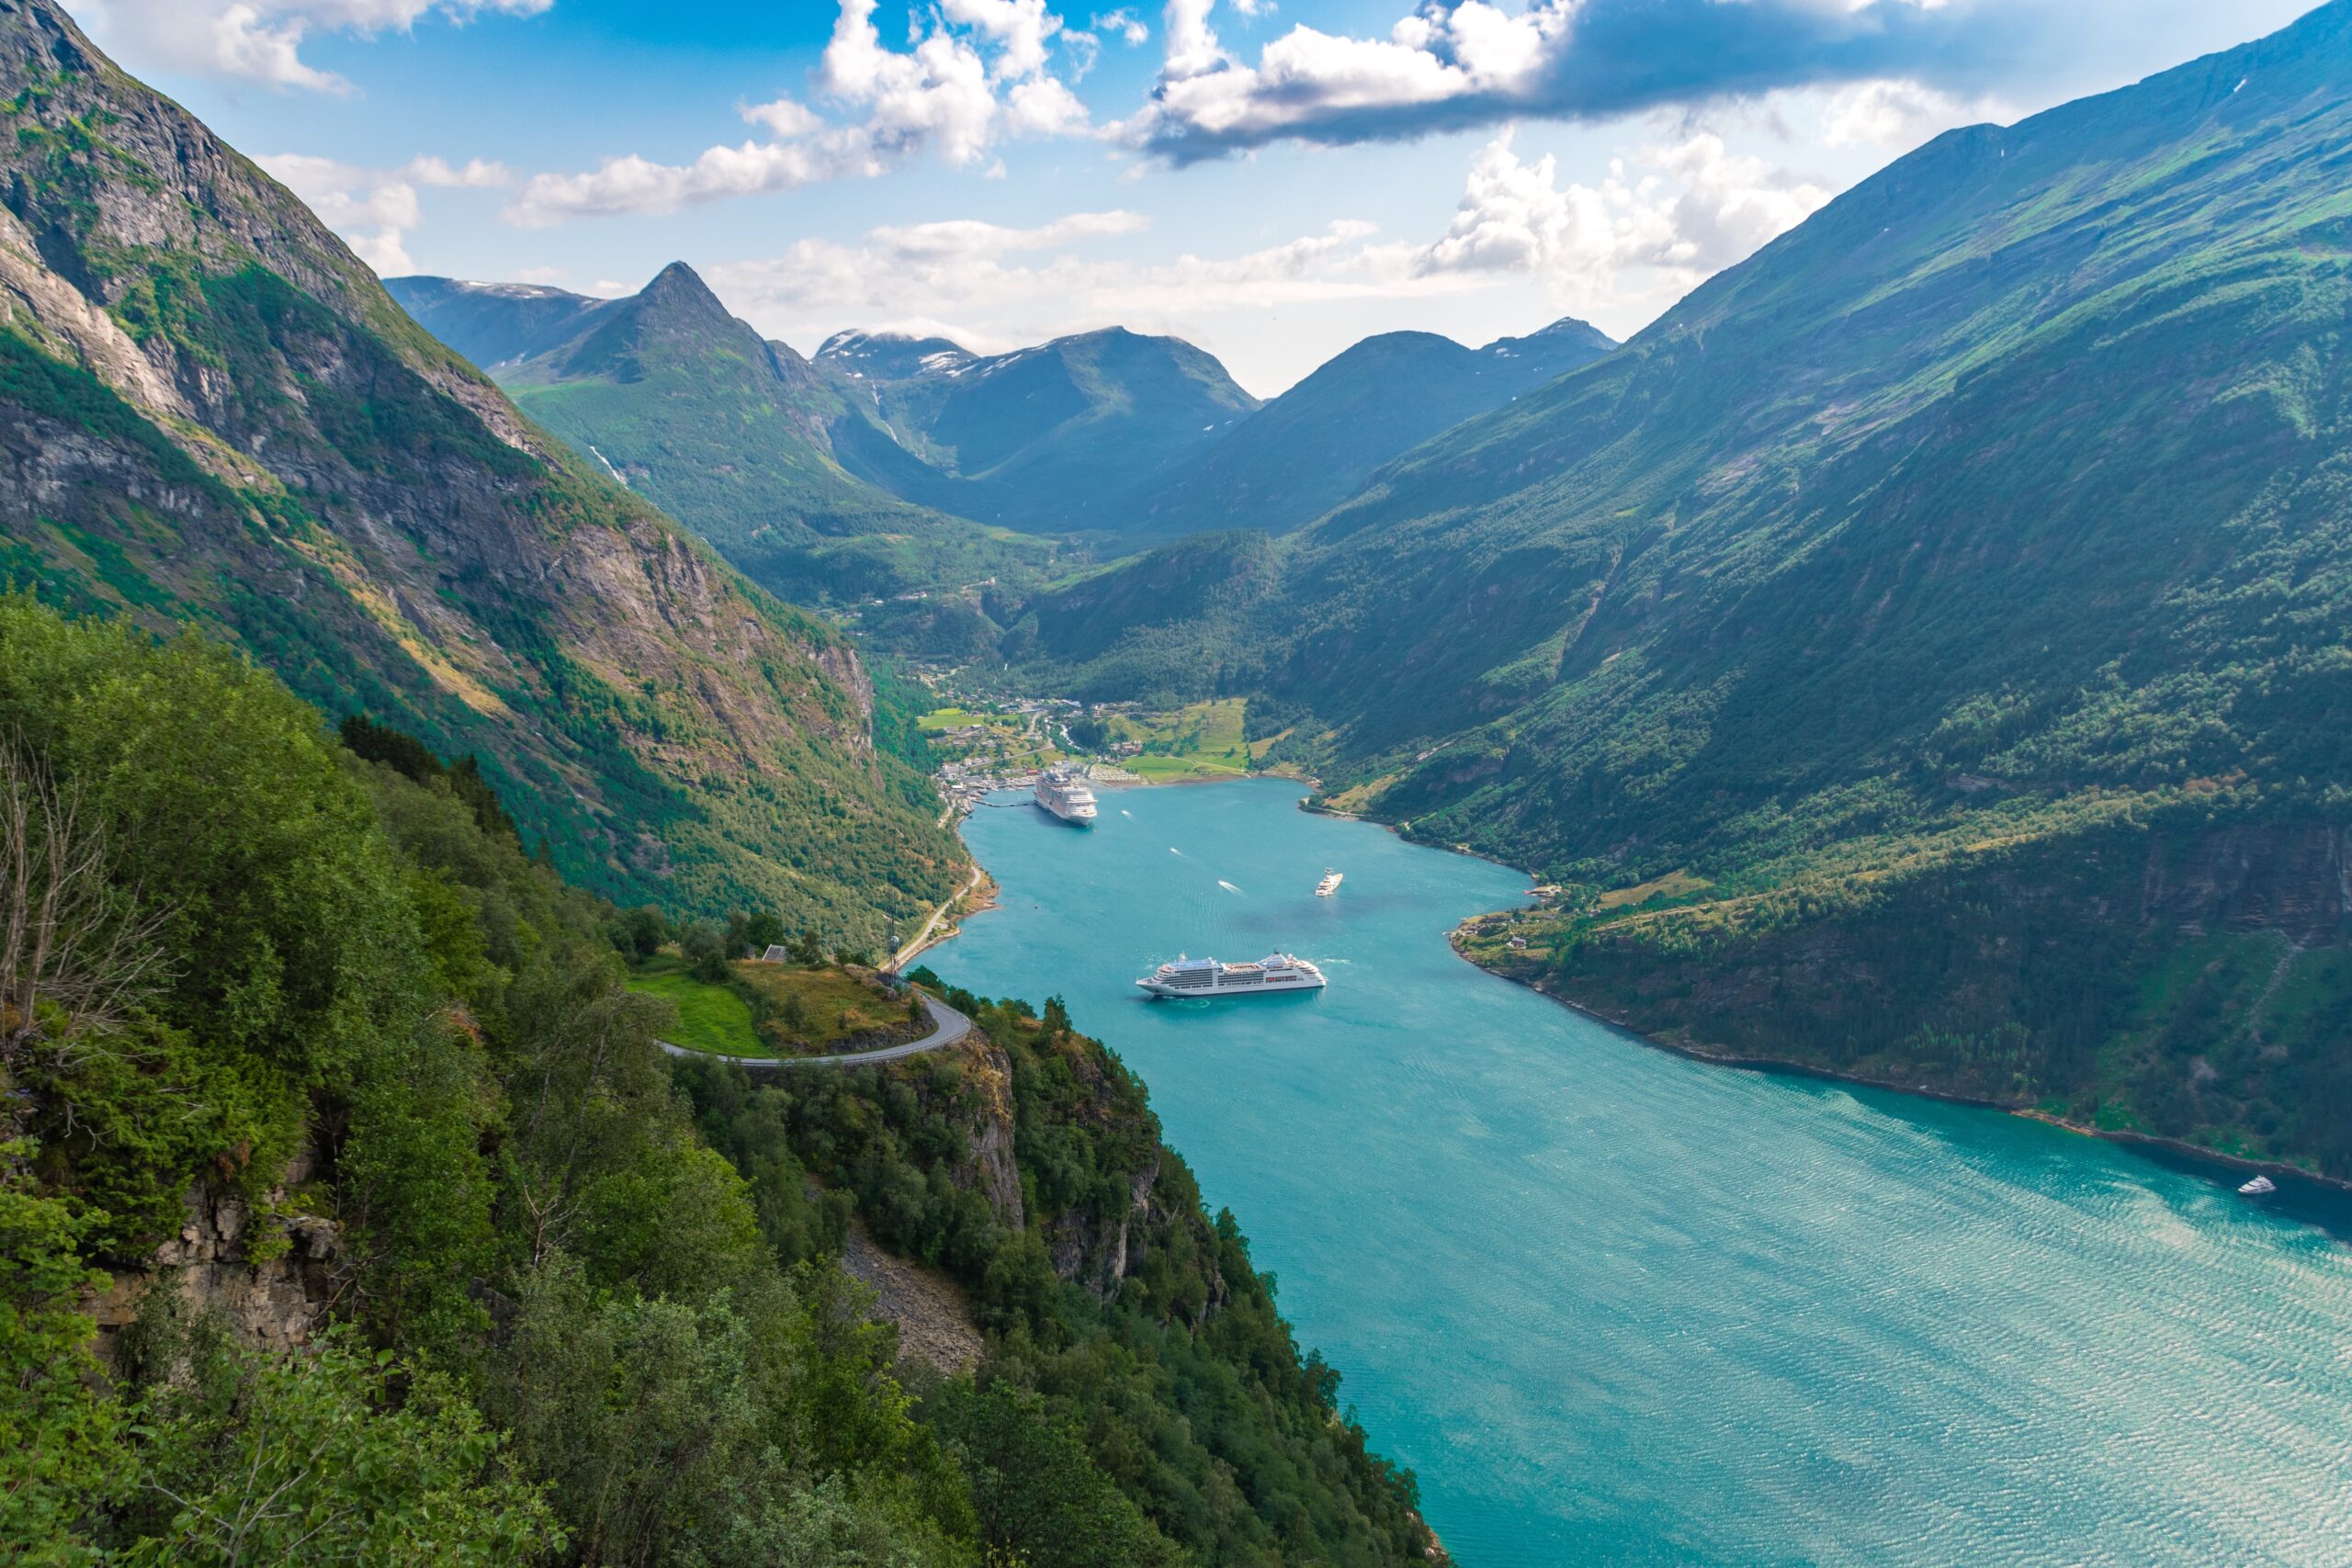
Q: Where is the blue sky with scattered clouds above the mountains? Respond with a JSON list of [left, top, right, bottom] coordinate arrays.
[[83, 0, 2310, 395]]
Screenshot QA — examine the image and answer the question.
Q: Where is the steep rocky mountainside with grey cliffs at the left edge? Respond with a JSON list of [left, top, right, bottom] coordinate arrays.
[[0, 0, 965, 938]]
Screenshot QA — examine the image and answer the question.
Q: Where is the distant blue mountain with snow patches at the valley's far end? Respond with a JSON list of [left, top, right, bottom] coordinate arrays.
[[816, 327, 1259, 534]]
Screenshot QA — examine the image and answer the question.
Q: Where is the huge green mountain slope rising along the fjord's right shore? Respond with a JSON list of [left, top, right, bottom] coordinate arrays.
[[1037, 0, 2352, 1173]]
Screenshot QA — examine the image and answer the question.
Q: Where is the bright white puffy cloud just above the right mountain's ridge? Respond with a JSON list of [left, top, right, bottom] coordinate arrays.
[[1414, 131, 1830, 317]]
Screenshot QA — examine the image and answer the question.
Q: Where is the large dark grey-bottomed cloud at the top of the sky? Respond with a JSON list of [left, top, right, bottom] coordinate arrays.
[[1122, 0, 2088, 163]]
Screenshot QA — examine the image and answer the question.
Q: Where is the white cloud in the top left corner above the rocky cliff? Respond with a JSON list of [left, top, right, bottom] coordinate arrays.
[[75, 0, 555, 92]]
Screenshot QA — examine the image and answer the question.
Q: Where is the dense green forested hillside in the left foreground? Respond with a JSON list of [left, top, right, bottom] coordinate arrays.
[[0, 594, 1430, 1568]]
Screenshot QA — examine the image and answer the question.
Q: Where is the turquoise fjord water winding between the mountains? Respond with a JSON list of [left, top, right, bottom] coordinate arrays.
[[924, 781, 2352, 1568]]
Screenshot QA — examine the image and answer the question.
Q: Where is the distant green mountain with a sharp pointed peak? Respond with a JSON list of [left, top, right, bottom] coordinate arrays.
[[386, 261, 1049, 602]]
